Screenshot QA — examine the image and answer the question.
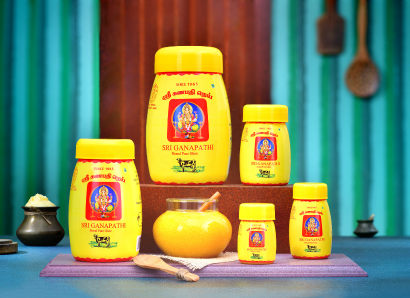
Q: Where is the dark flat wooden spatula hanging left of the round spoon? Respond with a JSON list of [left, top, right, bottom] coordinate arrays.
[[317, 0, 345, 55]]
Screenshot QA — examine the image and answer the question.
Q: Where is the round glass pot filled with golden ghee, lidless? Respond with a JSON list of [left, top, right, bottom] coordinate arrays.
[[153, 199, 232, 258]]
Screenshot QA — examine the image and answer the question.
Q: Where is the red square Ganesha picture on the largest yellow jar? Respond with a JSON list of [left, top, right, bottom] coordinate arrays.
[[167, 98, 209, 142]]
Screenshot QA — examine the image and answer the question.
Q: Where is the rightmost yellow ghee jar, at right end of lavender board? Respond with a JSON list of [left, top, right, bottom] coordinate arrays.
[[289, 183, 332, 259]]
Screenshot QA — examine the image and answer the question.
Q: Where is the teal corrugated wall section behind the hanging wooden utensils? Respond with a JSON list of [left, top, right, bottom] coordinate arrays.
[[271, 0, 410, 235]]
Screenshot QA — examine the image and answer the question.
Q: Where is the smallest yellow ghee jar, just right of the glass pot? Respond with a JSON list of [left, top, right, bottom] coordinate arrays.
[[238, 203, 276, 265]]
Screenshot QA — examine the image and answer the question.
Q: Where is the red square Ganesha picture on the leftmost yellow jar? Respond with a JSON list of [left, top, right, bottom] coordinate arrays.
[[86, 182, 122, 220]]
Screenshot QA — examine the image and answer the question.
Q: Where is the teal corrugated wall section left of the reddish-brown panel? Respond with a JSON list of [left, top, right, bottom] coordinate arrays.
[[0, 0, 99, 234]]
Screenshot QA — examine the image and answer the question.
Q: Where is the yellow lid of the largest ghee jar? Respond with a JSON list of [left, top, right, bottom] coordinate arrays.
[[155, 46, 223, 73]]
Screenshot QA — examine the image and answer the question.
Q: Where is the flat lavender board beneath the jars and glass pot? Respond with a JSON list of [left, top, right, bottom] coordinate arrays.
[[40, 254, 367, 278]]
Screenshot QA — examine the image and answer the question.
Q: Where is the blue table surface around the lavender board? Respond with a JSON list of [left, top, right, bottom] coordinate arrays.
[[0, 236, 410, 298]]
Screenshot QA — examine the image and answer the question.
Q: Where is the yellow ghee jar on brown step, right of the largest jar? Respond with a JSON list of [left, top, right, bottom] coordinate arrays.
[[239, 104, 290, 185]]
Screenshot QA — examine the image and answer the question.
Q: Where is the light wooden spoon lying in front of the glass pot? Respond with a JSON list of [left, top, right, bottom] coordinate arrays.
[[133, 255, 199, 281]]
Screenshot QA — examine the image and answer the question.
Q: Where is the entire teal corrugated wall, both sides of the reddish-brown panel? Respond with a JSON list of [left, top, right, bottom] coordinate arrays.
[[0, 0, 410, 235]]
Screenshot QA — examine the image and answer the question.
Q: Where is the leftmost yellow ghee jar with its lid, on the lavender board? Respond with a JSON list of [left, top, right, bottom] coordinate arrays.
[[69, 139, 142, 262]]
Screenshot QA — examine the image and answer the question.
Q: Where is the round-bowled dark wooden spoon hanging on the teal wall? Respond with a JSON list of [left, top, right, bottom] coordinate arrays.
[[345, 0, 379, 97]]
